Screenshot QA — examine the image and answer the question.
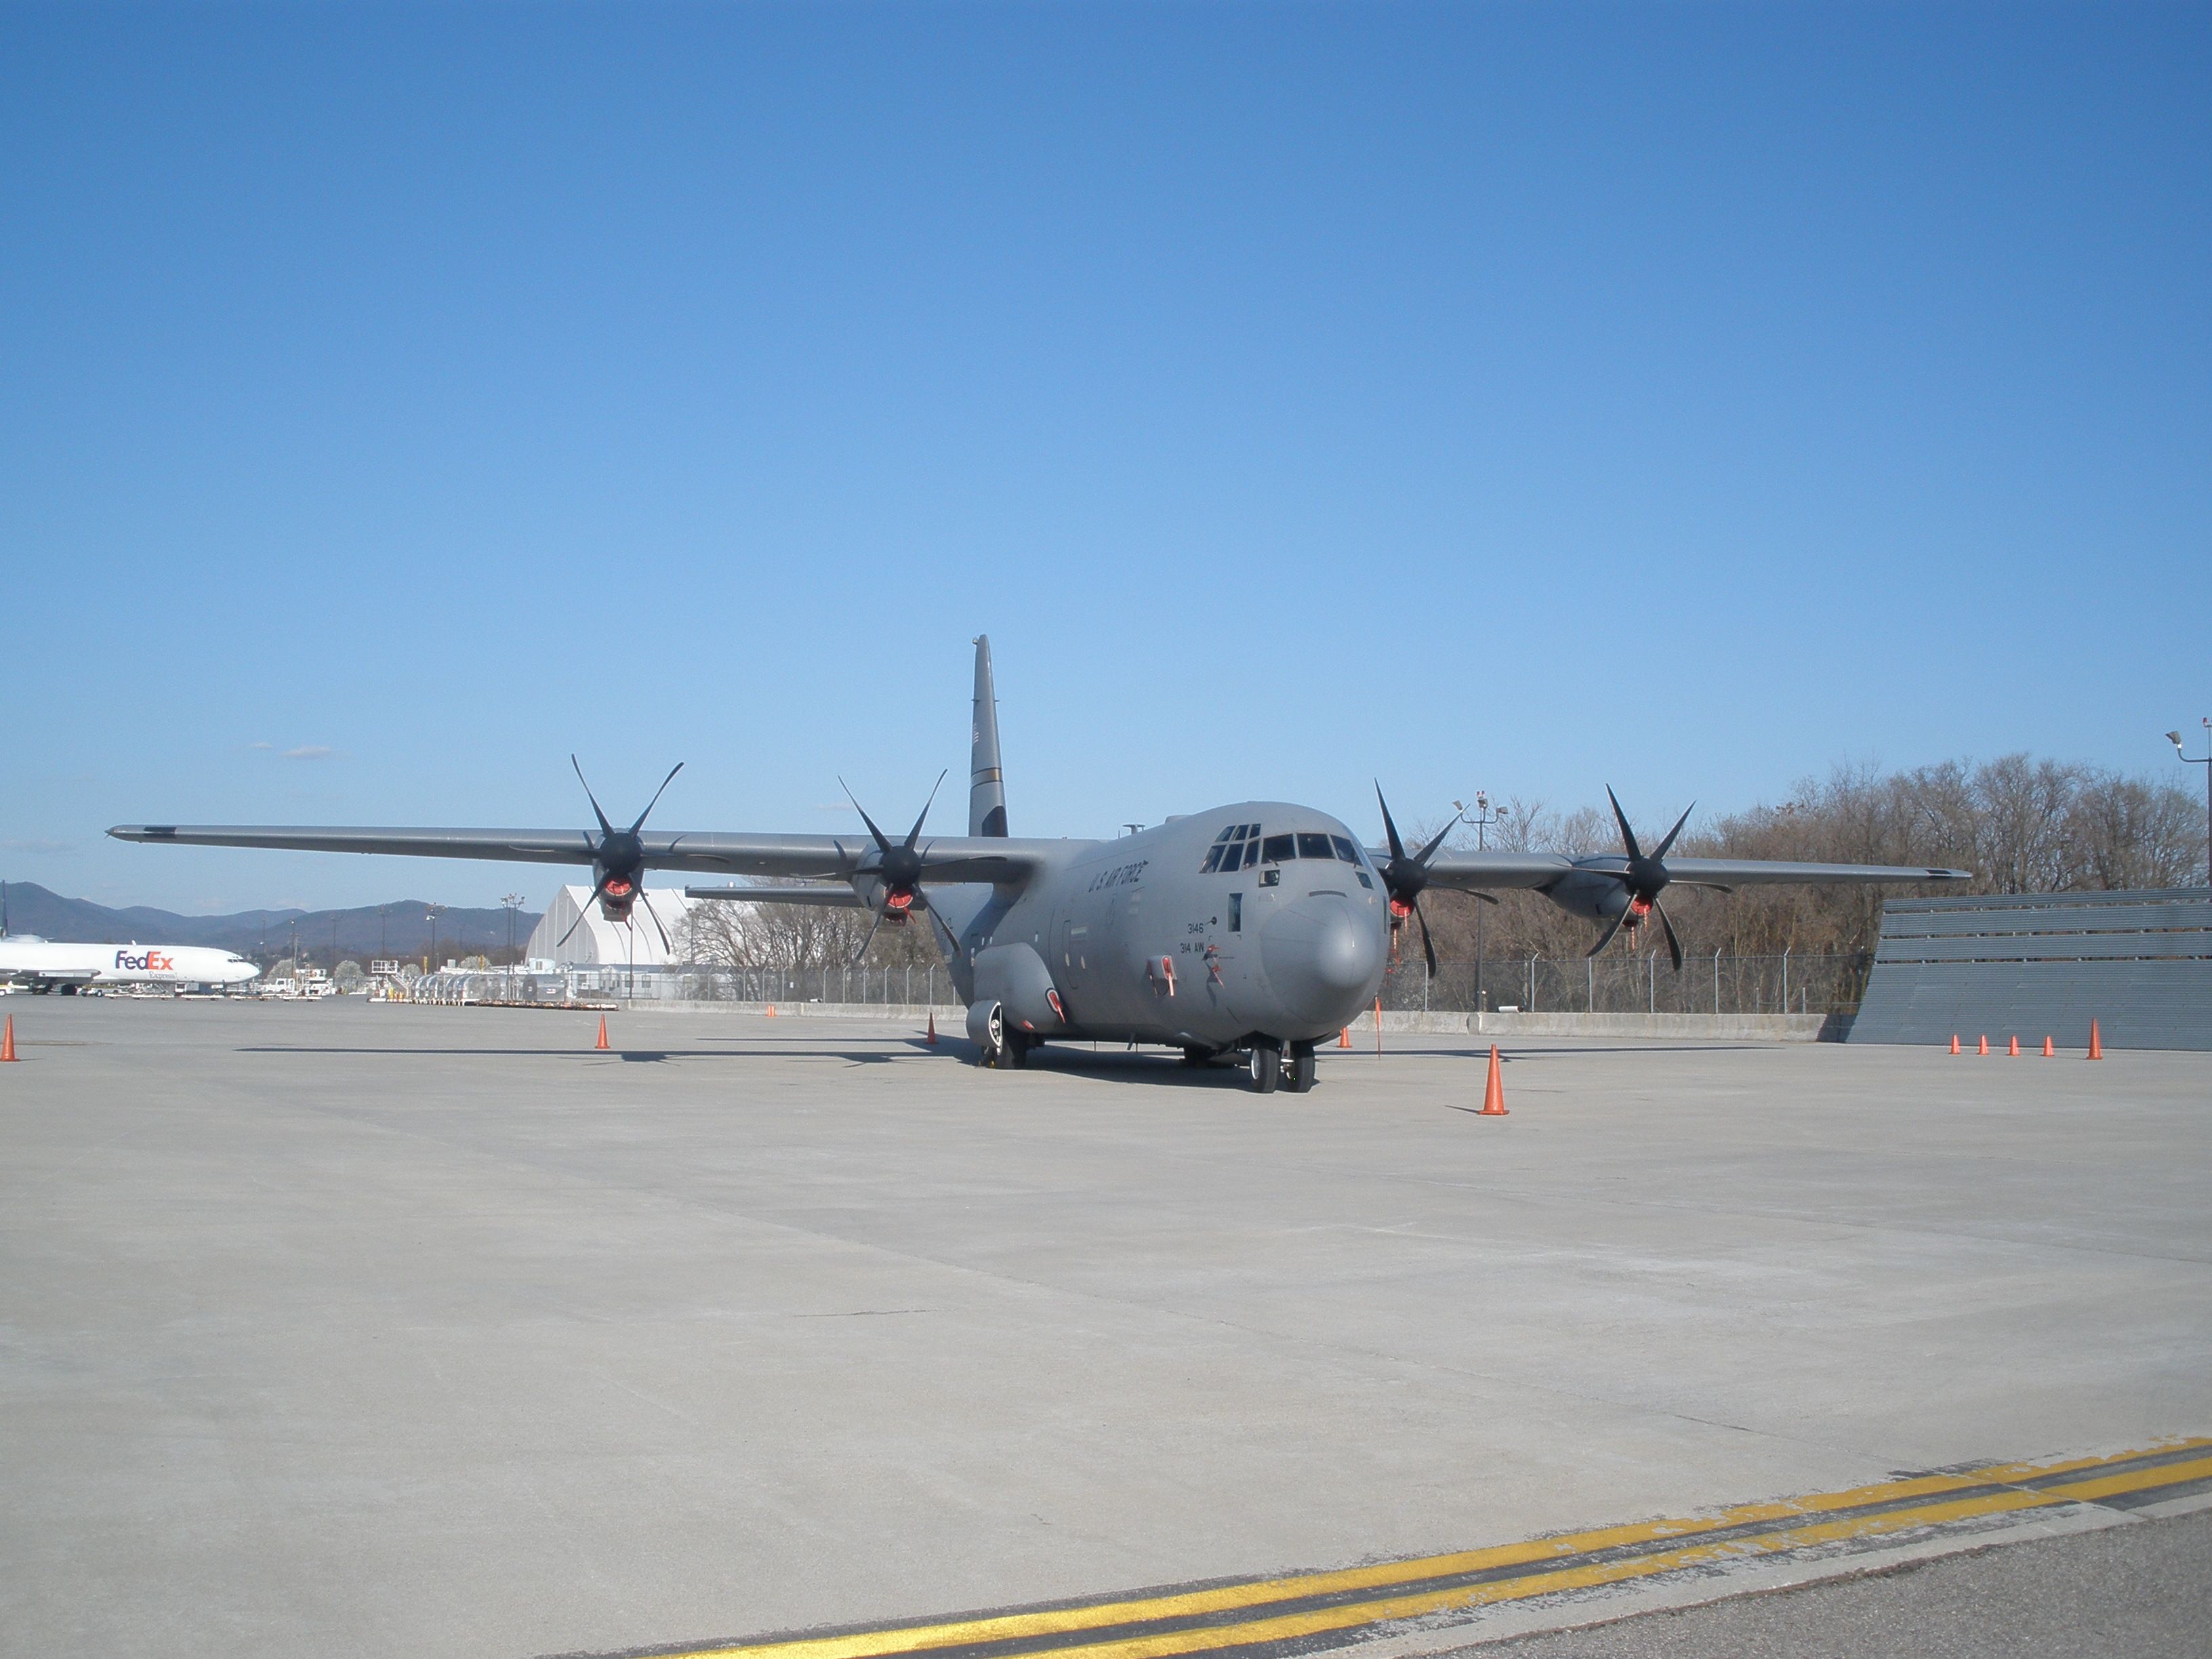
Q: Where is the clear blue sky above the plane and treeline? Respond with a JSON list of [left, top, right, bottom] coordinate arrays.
[[0, 5, 2212, 909]]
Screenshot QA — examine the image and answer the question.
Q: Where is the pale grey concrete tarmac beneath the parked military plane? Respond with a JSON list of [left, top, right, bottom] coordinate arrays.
[[0, 998, 2212, 1659]]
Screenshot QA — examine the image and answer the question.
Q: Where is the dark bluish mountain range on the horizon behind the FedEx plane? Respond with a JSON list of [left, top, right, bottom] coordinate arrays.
[[7, 880, 539, 966]]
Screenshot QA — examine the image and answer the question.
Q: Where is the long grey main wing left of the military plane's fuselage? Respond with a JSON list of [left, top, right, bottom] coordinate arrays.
[[108, 823, 1062, 885]]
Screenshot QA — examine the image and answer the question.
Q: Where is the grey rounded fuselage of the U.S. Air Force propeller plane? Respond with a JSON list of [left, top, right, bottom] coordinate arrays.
[[929, 801, 1389, 1048]]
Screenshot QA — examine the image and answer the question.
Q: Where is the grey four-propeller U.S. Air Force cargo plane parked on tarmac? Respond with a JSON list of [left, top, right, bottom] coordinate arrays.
[[108, 637, 1967, 1092]]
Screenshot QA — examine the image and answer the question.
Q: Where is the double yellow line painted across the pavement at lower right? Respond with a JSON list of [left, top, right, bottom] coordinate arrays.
[[668, 1440, 2212, 1659]]
